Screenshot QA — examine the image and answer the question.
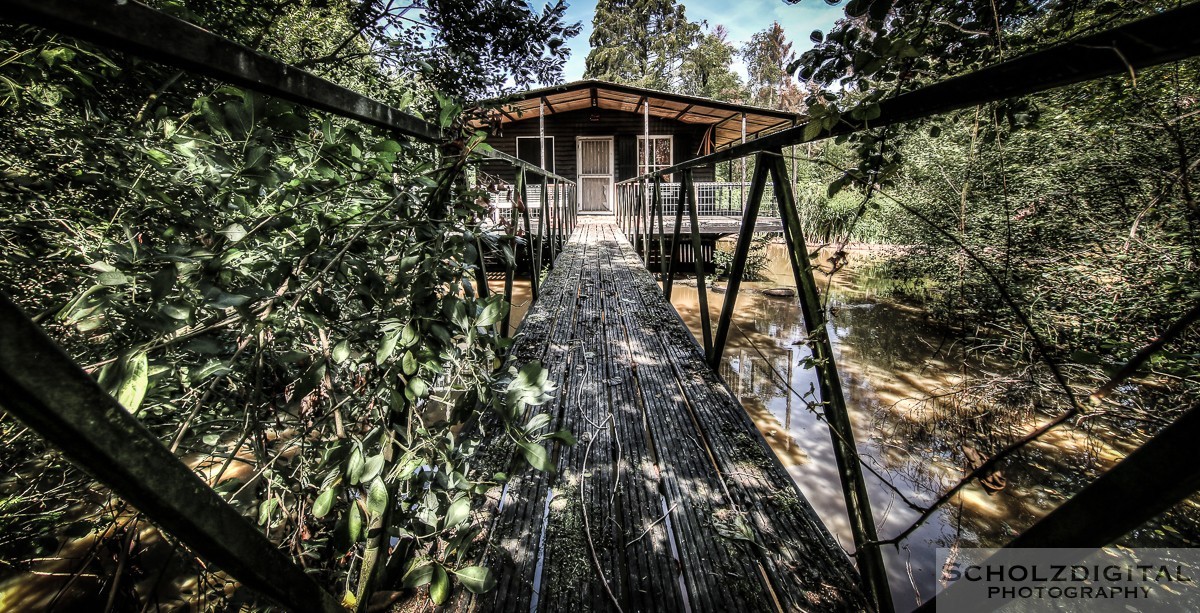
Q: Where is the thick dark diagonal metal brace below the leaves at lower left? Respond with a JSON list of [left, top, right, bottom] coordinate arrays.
[[0, 293, 344, 613]]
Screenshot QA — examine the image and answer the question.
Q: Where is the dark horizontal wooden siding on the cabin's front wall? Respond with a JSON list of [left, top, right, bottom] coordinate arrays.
[[482, 109, 715, 187]]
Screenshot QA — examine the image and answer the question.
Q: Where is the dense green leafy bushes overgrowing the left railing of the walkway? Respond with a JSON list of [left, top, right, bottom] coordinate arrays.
[[0, 1, 570, 609]]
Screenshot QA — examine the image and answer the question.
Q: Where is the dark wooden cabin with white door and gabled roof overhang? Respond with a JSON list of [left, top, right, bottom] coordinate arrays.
[[475, 79, 800, 212]]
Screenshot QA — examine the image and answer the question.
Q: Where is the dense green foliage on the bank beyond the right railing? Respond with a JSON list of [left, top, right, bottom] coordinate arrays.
[[793, 0, 1200, 539]]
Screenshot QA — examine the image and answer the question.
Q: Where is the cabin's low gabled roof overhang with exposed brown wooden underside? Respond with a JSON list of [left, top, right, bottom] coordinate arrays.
[[473, 79, 804, 149]]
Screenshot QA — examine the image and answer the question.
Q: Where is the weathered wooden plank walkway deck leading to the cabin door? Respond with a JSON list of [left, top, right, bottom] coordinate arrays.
[[458, 217, 868, 613]]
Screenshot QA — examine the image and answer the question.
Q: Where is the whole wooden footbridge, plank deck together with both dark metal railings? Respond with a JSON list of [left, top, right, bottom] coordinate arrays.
[[0, 0, 1200, 613]]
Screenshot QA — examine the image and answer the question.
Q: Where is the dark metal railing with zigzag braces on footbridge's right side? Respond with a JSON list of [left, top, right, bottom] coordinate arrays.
[[616, 4, 1200, 611]]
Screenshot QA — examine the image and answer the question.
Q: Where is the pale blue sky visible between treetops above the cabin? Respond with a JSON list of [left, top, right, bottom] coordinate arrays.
[[563, 0, 842, 82]]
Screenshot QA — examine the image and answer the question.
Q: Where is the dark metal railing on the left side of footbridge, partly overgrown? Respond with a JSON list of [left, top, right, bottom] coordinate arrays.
[[0, 0, 576, 613]]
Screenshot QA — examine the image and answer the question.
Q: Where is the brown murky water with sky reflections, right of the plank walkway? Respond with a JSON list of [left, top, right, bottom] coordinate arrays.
[[672, 245, 1185, 611]]
